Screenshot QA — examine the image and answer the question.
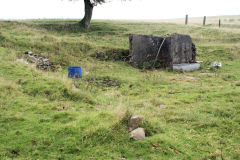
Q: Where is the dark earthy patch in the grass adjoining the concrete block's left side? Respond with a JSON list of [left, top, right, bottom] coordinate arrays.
[[91, 49, 130, 61]]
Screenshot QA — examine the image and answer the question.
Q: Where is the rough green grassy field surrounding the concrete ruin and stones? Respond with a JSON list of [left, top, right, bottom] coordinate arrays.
[[0, 17, 240, 160]]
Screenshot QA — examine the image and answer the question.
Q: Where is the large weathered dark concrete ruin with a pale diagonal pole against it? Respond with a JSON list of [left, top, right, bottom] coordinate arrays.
[[129, 34, 196, 68]]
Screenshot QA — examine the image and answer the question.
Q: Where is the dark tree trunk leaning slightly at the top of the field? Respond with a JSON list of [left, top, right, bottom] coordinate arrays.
[[80, 0, 93, 29]]
